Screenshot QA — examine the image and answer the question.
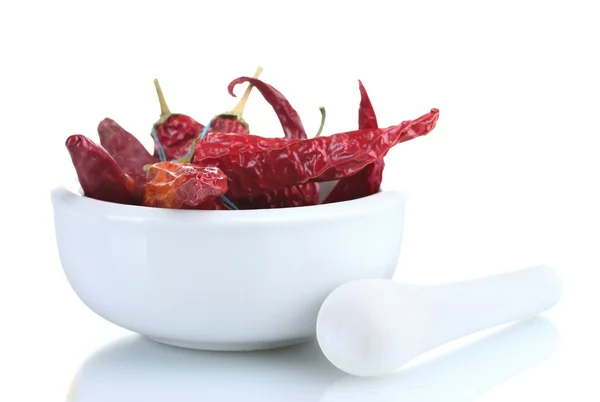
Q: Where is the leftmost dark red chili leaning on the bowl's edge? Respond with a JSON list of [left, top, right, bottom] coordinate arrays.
[[65, 135, 137, 204]]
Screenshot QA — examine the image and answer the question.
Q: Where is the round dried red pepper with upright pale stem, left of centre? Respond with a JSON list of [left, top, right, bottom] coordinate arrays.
[[152, 80, 204, 161]]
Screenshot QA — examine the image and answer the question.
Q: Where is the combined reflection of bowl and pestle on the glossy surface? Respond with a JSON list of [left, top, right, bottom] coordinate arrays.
[[71, 318, 558, 402]]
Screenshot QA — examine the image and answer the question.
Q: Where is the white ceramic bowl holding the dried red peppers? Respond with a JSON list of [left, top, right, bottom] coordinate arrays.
[[52, 186, 406, 350]]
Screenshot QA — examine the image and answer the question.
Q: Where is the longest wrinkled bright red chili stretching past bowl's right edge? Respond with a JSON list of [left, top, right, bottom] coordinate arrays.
[[193, 109, 439, 197]]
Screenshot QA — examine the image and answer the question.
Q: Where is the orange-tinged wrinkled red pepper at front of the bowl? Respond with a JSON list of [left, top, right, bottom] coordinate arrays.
[[143, 162, 227, 209]]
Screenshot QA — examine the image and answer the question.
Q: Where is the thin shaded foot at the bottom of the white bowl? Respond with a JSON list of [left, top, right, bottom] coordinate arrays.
[[147, 337, 313, 352]]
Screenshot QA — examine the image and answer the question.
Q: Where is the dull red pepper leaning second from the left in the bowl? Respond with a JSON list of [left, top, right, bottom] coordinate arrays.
[[98, 119, 158, 198]]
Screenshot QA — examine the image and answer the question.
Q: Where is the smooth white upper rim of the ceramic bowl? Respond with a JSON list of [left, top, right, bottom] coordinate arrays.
[[50, 181, 408, 222]]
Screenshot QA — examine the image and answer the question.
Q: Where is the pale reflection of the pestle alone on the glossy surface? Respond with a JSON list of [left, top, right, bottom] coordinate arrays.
[[322, 318, 558, 402]]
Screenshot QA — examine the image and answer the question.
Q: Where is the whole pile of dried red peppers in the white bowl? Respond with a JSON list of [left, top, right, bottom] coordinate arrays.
[[66, 68, 439, 209]]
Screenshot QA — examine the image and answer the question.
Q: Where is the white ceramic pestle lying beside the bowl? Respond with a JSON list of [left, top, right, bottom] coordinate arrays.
[[317, 265, 561, 377]]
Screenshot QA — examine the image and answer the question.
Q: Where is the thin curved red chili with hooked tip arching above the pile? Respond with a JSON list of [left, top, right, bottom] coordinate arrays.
[[228, 77, 306, 139]]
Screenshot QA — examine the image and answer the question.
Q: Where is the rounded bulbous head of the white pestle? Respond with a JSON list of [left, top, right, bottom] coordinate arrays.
[[317, 279, 427, 377]]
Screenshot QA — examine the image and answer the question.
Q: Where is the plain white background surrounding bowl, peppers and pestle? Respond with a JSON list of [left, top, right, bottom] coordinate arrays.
[[0, 0, 600, 401]]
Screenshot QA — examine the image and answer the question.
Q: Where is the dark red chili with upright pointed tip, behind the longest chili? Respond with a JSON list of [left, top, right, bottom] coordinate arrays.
[[323, 80, 385, 204]]
